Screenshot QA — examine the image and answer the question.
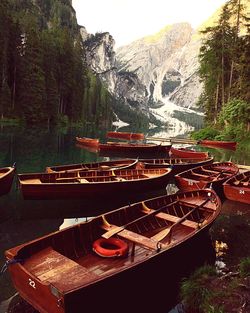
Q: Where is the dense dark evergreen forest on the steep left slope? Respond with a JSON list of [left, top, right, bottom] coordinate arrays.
[[0, 0, 113, 126]]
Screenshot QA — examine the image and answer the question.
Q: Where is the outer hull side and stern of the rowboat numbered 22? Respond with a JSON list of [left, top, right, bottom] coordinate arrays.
[[9, 227, 214, 313]]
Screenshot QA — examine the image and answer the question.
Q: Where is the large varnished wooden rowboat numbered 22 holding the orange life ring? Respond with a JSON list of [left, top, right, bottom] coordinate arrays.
[[5, 189, 221, 313]]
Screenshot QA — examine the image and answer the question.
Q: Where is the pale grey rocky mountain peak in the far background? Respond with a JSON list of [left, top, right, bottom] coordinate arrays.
[[116, 23, 202, 107]]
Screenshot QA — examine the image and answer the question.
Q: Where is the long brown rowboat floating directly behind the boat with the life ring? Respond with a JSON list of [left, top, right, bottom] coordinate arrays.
[[18, 168, 171, 199]]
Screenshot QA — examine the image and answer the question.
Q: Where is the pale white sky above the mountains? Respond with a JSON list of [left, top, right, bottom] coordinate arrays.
[[72, 0, 226, 48]]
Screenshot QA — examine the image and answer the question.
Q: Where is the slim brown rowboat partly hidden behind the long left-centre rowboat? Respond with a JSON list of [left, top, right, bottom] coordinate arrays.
[[45, 159, 138, 173]]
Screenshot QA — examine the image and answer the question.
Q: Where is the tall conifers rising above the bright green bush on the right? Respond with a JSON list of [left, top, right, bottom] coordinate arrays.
[[198, 0, 250, 124]]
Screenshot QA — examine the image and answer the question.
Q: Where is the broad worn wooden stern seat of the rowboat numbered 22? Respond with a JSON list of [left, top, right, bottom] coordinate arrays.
[[24, 247, 98, 292]]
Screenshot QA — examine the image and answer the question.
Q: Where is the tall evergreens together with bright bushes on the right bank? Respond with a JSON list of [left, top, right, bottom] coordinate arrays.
[[193, 0, 250, 141]]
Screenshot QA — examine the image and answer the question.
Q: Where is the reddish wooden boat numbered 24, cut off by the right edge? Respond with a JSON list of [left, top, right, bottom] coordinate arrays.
[[223, 171, 250, 204]]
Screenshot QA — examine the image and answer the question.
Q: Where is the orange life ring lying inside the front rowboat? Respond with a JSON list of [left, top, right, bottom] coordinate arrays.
[[93, 237, 128, 257]]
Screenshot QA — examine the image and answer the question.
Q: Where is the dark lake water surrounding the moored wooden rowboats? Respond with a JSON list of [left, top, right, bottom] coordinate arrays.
[[0, 127, 250, 313]]
